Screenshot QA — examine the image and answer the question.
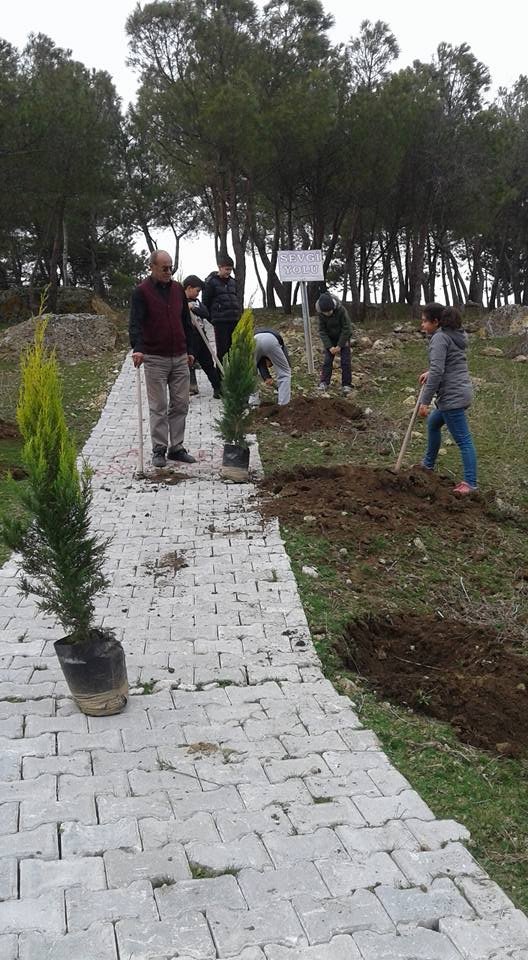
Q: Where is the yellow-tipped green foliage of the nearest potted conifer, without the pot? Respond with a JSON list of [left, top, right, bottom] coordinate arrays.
[[1, 318, 108, 642]]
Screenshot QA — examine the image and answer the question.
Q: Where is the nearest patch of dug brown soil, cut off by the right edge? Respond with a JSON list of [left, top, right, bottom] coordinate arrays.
[[338, 615, 528, 756]]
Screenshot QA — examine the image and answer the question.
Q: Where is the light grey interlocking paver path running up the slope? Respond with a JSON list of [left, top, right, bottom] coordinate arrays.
[[0, 360, 528, 960]]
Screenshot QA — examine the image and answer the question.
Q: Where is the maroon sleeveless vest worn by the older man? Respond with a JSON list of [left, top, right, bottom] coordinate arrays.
[[139, 279, 187, 357]]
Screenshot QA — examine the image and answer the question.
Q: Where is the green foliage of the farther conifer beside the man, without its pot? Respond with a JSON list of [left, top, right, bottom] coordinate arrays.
[[216, 310, 257, 447]]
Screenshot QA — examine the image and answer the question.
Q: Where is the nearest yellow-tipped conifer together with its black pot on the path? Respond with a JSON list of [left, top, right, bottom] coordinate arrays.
[[1, 318, 128, 716]]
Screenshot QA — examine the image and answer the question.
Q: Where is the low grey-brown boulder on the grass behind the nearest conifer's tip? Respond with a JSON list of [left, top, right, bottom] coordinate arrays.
[[0, 313, 117, 363]]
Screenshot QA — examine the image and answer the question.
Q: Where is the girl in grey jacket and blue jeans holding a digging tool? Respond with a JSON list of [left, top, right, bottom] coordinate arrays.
[[419, 303, 477, 495]]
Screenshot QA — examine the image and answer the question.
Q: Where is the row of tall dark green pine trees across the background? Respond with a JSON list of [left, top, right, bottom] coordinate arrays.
[[0, 0, 528, 313]]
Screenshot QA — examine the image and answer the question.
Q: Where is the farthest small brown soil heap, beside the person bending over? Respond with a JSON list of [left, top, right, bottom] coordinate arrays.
[[255, 397, 365, 434]]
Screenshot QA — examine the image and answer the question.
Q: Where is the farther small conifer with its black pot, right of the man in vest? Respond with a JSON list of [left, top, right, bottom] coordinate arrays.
[[216, 310, 257, 483]]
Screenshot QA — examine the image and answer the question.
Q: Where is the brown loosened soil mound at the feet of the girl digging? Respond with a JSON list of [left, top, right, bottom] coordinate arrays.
[[259, 465, 504, 541]]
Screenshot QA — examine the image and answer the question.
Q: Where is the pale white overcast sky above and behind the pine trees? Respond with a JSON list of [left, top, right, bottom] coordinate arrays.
[[0, 0, 528, 290]]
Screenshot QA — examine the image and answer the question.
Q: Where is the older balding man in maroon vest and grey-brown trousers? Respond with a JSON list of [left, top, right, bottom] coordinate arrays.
[[129, 250, 196, 467]]
